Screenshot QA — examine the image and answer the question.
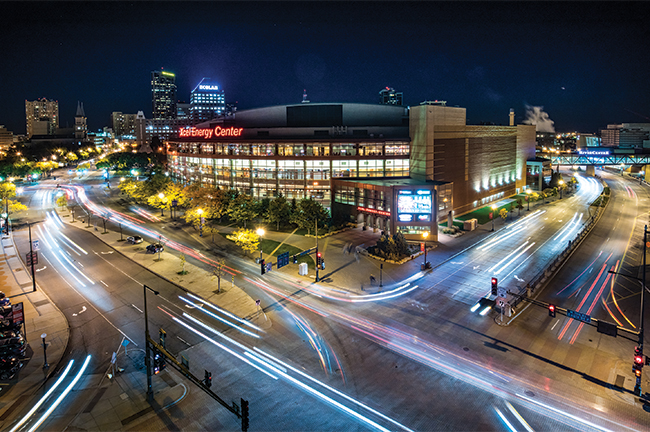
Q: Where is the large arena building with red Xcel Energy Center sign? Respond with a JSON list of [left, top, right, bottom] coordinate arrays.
[[166, 102, 535, 241]]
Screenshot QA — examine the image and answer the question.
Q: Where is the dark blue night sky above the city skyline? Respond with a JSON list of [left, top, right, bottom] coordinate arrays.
[[0, 2, 650, 134]]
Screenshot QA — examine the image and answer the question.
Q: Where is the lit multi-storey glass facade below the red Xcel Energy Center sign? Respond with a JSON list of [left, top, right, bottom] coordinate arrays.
[[168, 140, 409, 205]]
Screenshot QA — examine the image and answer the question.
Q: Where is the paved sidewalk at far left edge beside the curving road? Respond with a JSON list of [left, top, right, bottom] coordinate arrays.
[[0, 231, 70, 429]]
